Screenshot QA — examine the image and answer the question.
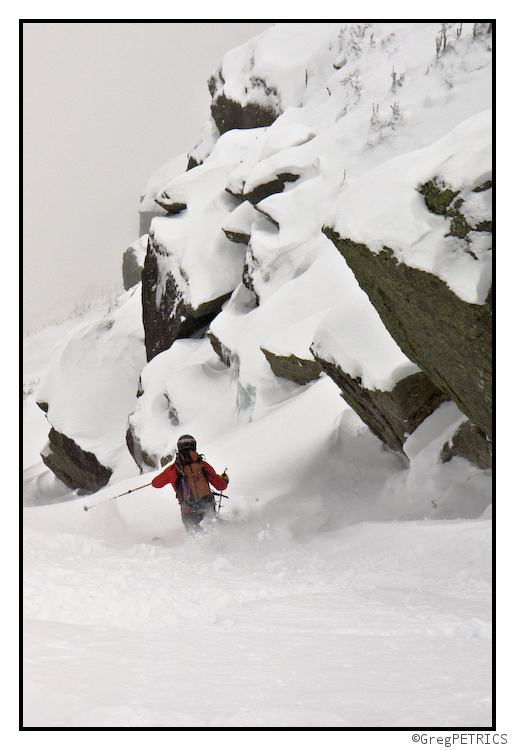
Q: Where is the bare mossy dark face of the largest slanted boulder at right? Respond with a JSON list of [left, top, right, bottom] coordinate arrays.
[[323, 227, 492, 436]]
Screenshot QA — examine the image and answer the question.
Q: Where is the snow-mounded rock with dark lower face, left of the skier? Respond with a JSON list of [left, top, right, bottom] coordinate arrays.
[[37, 285, 145, 491]]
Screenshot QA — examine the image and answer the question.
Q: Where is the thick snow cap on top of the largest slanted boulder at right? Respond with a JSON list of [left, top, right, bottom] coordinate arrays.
[[326, 110, 492, 304]]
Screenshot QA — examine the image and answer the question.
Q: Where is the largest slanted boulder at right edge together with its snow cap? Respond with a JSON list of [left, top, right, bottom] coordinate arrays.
[[324, 111, 492, 444]]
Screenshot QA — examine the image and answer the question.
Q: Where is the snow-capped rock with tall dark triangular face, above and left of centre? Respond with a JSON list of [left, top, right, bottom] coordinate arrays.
[[142, 131, 256, 360]]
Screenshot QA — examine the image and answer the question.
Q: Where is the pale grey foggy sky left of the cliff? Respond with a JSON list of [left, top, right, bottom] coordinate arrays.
[[23, 22, 271, 331]]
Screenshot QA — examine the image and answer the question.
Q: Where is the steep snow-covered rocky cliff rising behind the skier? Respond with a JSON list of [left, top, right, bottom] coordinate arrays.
[[34, 22, 492, 494]]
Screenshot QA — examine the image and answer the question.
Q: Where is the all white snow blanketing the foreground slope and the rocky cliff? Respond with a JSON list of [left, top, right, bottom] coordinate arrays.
[[23, 22, 492, 729]]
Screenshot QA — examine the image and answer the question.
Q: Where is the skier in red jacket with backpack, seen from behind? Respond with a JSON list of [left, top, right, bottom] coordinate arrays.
[[152, 435, 229, 532]]
